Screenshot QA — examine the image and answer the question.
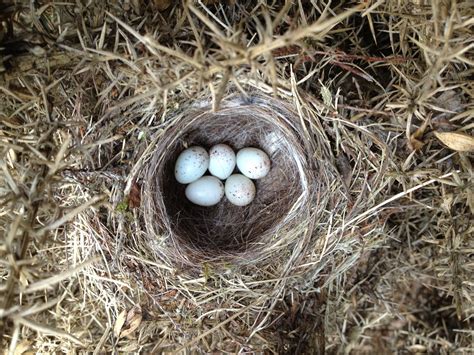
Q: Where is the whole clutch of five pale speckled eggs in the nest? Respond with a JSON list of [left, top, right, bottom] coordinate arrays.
[[174, 144, 271, 207]]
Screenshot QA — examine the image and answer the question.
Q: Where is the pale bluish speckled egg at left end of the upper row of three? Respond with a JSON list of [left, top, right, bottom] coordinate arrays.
[[174, 146, 209, 184]]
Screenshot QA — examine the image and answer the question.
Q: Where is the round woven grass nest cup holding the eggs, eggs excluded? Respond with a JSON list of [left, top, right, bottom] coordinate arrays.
[[142, 95, 316, 265]]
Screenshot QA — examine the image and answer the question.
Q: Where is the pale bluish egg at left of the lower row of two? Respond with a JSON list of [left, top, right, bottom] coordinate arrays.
[[185, 176, 224, 207]]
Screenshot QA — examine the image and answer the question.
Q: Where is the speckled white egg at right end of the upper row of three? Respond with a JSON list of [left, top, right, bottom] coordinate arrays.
[[237, 148, 270, 179]]
